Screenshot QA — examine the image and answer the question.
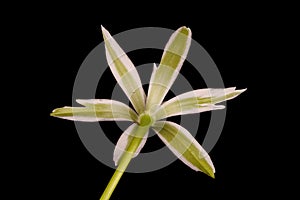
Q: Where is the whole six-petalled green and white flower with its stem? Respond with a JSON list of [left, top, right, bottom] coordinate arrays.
[[51, 27, 245, 199]]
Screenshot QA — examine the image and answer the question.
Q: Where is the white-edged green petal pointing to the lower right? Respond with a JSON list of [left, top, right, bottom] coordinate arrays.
[[153, 121, 215, 178]]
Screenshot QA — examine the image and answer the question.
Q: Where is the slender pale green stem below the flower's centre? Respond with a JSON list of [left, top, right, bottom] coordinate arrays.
[[100, 126, 149, 200]]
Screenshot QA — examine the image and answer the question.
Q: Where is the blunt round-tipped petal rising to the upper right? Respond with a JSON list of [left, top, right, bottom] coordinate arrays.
[[146, 27, 192, 110]]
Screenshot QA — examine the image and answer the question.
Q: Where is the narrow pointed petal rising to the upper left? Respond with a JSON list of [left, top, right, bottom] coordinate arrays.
[[102, 26, 146, 113]]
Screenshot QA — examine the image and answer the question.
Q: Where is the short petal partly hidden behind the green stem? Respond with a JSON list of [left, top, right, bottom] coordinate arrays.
[[114, 124, 149, 165]]
